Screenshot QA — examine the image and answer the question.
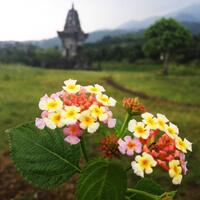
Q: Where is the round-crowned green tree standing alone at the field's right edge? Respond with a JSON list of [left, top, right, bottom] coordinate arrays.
[[144, 18, 192, 75]]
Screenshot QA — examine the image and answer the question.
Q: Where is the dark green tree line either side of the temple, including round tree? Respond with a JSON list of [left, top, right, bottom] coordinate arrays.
[[0, 19, 200, 71]]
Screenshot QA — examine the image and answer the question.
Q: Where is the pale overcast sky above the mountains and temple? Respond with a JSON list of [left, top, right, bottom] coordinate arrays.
[[0, 0, 200, 41]]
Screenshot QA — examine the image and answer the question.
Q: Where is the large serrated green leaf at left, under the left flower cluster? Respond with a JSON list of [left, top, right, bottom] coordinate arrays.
[[9, 122, 80, 188]]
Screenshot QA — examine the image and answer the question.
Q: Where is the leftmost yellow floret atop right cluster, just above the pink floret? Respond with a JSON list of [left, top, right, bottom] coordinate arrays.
[[128, 119, 150, 139]]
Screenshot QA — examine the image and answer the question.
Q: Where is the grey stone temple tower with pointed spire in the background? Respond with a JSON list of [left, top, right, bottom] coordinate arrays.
[[58, 4, 88, 60]]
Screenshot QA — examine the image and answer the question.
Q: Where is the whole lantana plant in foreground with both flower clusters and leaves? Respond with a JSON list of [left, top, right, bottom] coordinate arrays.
[[9, 79, 192, 200]]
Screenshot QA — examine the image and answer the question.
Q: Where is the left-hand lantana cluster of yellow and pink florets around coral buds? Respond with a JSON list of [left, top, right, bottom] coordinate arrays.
[[35, 79, 116, 144]]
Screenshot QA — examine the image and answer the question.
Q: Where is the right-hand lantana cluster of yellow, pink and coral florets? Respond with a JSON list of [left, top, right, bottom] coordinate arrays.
[[118, 112, 192, 184]]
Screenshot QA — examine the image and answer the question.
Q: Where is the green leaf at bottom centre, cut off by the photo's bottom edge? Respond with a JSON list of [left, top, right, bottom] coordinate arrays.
[[77, 159, 127, 200]]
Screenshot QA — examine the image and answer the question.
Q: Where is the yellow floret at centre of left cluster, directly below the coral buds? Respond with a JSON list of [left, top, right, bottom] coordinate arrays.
[[63, 106, 80, 125]]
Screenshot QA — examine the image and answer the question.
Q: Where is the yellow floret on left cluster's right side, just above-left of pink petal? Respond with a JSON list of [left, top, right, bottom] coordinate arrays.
[[89, 105, 108, 121]]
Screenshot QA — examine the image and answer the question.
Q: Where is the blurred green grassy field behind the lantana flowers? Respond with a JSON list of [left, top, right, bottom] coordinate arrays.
[[0, 63, 200, 198]]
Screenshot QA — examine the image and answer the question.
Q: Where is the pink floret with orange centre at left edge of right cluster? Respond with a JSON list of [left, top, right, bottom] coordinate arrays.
[[118, 136, 142, 156]]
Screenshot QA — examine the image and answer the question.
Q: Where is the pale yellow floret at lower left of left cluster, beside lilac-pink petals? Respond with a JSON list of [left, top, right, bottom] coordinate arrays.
[[44, 112, 65, 129]]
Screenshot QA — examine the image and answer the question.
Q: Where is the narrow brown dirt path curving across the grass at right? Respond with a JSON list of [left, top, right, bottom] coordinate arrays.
[[102, 77, 200, 108]]
